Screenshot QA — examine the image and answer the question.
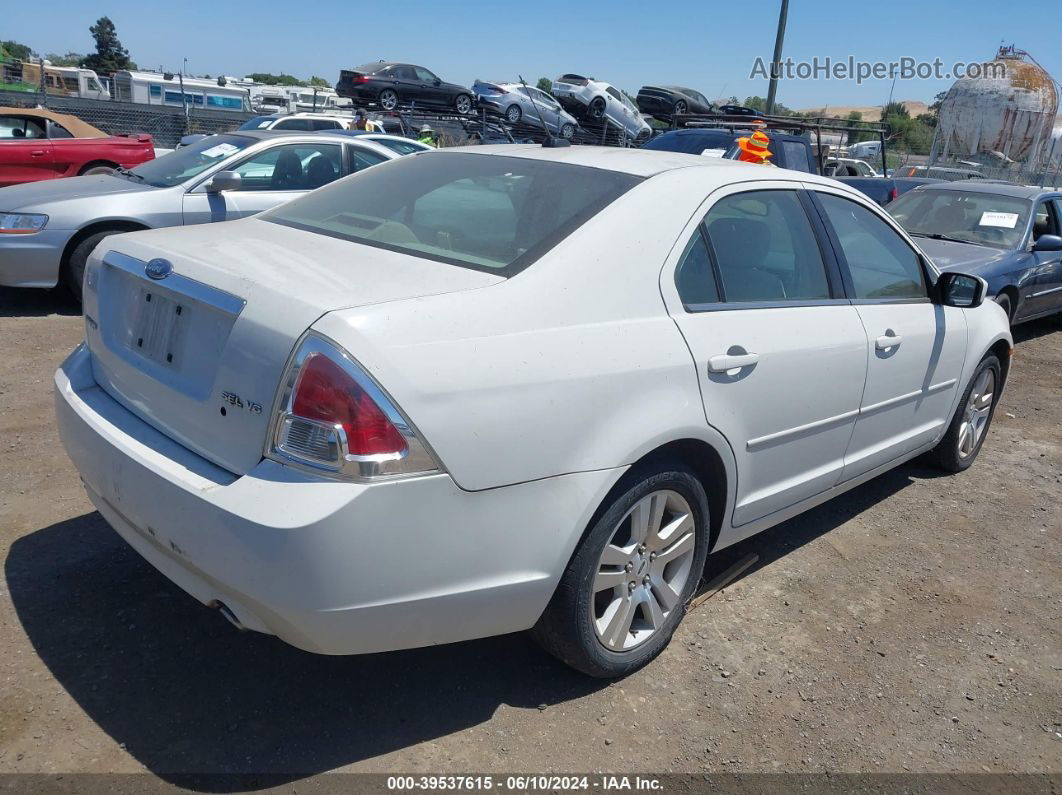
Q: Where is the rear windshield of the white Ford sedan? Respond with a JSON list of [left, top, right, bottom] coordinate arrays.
[[259, 152, 641, 276]]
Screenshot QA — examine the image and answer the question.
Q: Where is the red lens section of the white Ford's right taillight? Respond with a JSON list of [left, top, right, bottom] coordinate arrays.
[[291, 353, 407, 455]]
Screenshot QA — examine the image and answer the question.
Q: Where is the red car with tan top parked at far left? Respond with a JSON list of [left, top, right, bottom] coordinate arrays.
[[0, 107, 155, 188]]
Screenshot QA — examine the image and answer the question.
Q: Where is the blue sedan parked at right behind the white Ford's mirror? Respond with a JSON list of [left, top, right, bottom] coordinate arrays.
[[886, 182, 1062, 324]]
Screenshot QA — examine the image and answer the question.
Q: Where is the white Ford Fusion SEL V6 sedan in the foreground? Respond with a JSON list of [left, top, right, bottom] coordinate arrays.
[[55, 145, 1011, 676]]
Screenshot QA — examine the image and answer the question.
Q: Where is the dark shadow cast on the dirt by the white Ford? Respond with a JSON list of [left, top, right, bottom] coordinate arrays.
[[5, 456, 947, 790]]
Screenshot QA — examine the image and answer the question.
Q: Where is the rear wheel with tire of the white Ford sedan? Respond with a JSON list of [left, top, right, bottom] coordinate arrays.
[[532, 462, 709, 677]]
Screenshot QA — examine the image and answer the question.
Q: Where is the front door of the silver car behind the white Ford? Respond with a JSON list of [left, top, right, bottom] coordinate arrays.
[[184, 142, 346, 224]]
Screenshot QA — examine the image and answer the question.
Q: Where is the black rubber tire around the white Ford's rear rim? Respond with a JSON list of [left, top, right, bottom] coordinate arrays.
[[534, 464, 710, 677]]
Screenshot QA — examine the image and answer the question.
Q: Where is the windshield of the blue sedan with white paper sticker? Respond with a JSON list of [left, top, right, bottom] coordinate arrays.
[[886, 190, 1031, 249]]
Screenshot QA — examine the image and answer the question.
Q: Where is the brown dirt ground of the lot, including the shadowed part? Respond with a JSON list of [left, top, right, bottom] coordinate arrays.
[[0, 290, 1062, 782]]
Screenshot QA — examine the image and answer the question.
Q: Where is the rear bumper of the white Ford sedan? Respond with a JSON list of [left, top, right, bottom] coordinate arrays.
[[55, 347, 621, 654]]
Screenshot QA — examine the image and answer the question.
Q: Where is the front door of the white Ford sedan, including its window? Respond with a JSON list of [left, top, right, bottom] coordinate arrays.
[[813, 186, 966, 480]]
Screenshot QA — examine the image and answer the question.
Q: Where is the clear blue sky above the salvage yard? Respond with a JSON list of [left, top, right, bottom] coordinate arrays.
[[0, 0, 1062, 108]]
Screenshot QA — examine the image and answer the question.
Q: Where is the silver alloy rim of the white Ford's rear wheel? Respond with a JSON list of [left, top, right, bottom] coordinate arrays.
[[590, 489, 697, 652]]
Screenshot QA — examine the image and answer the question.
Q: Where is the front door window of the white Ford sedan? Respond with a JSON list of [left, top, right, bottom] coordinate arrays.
[[817, 193, 927, 300]]
